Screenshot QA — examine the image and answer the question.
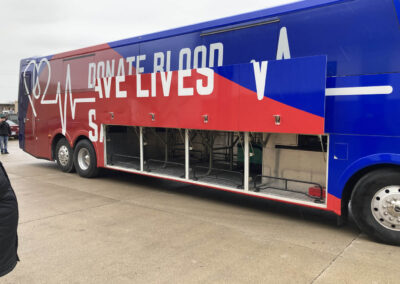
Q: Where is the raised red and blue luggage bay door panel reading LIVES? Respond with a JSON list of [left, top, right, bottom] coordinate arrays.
[[111, 56, 326, 134]]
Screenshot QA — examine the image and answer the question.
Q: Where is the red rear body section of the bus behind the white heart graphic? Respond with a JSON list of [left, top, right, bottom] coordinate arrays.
[[24, 44, 135, 162]]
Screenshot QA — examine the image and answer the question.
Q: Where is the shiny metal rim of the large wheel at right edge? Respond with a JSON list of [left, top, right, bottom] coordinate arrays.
[[371, 185, 400, 231]]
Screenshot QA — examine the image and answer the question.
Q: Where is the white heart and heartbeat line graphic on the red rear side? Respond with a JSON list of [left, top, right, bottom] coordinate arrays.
[[24, 58, 96, 135]]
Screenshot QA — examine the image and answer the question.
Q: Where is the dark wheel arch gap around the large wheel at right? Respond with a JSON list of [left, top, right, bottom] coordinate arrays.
[[342, 164, 400, 216]]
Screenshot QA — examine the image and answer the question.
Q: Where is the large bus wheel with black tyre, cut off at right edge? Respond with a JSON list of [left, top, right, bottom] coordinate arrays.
[[351, 169, 400, 245]]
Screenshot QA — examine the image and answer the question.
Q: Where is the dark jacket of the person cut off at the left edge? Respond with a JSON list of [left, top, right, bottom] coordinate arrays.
[[0, 162, 19, 277]]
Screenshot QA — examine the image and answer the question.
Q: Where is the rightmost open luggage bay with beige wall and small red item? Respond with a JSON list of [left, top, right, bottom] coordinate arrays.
[[253, 133, 328, 203]]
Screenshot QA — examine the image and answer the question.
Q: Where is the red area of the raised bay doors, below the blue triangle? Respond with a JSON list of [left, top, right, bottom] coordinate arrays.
[[96, 70, 324, 134]]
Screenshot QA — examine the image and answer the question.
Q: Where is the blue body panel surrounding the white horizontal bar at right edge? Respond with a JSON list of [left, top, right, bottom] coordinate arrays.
[[325, 74, 400, 136]]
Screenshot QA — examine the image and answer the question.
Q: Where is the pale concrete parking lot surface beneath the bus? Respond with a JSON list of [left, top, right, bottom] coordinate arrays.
[[0, 141, 400, 283]]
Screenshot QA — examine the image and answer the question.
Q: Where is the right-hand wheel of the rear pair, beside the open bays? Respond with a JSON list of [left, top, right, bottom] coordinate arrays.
[[74, 139, 99, 178]]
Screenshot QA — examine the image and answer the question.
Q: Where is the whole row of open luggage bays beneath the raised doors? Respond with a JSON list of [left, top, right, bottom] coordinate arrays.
[[106, 125, 328, 203]]
